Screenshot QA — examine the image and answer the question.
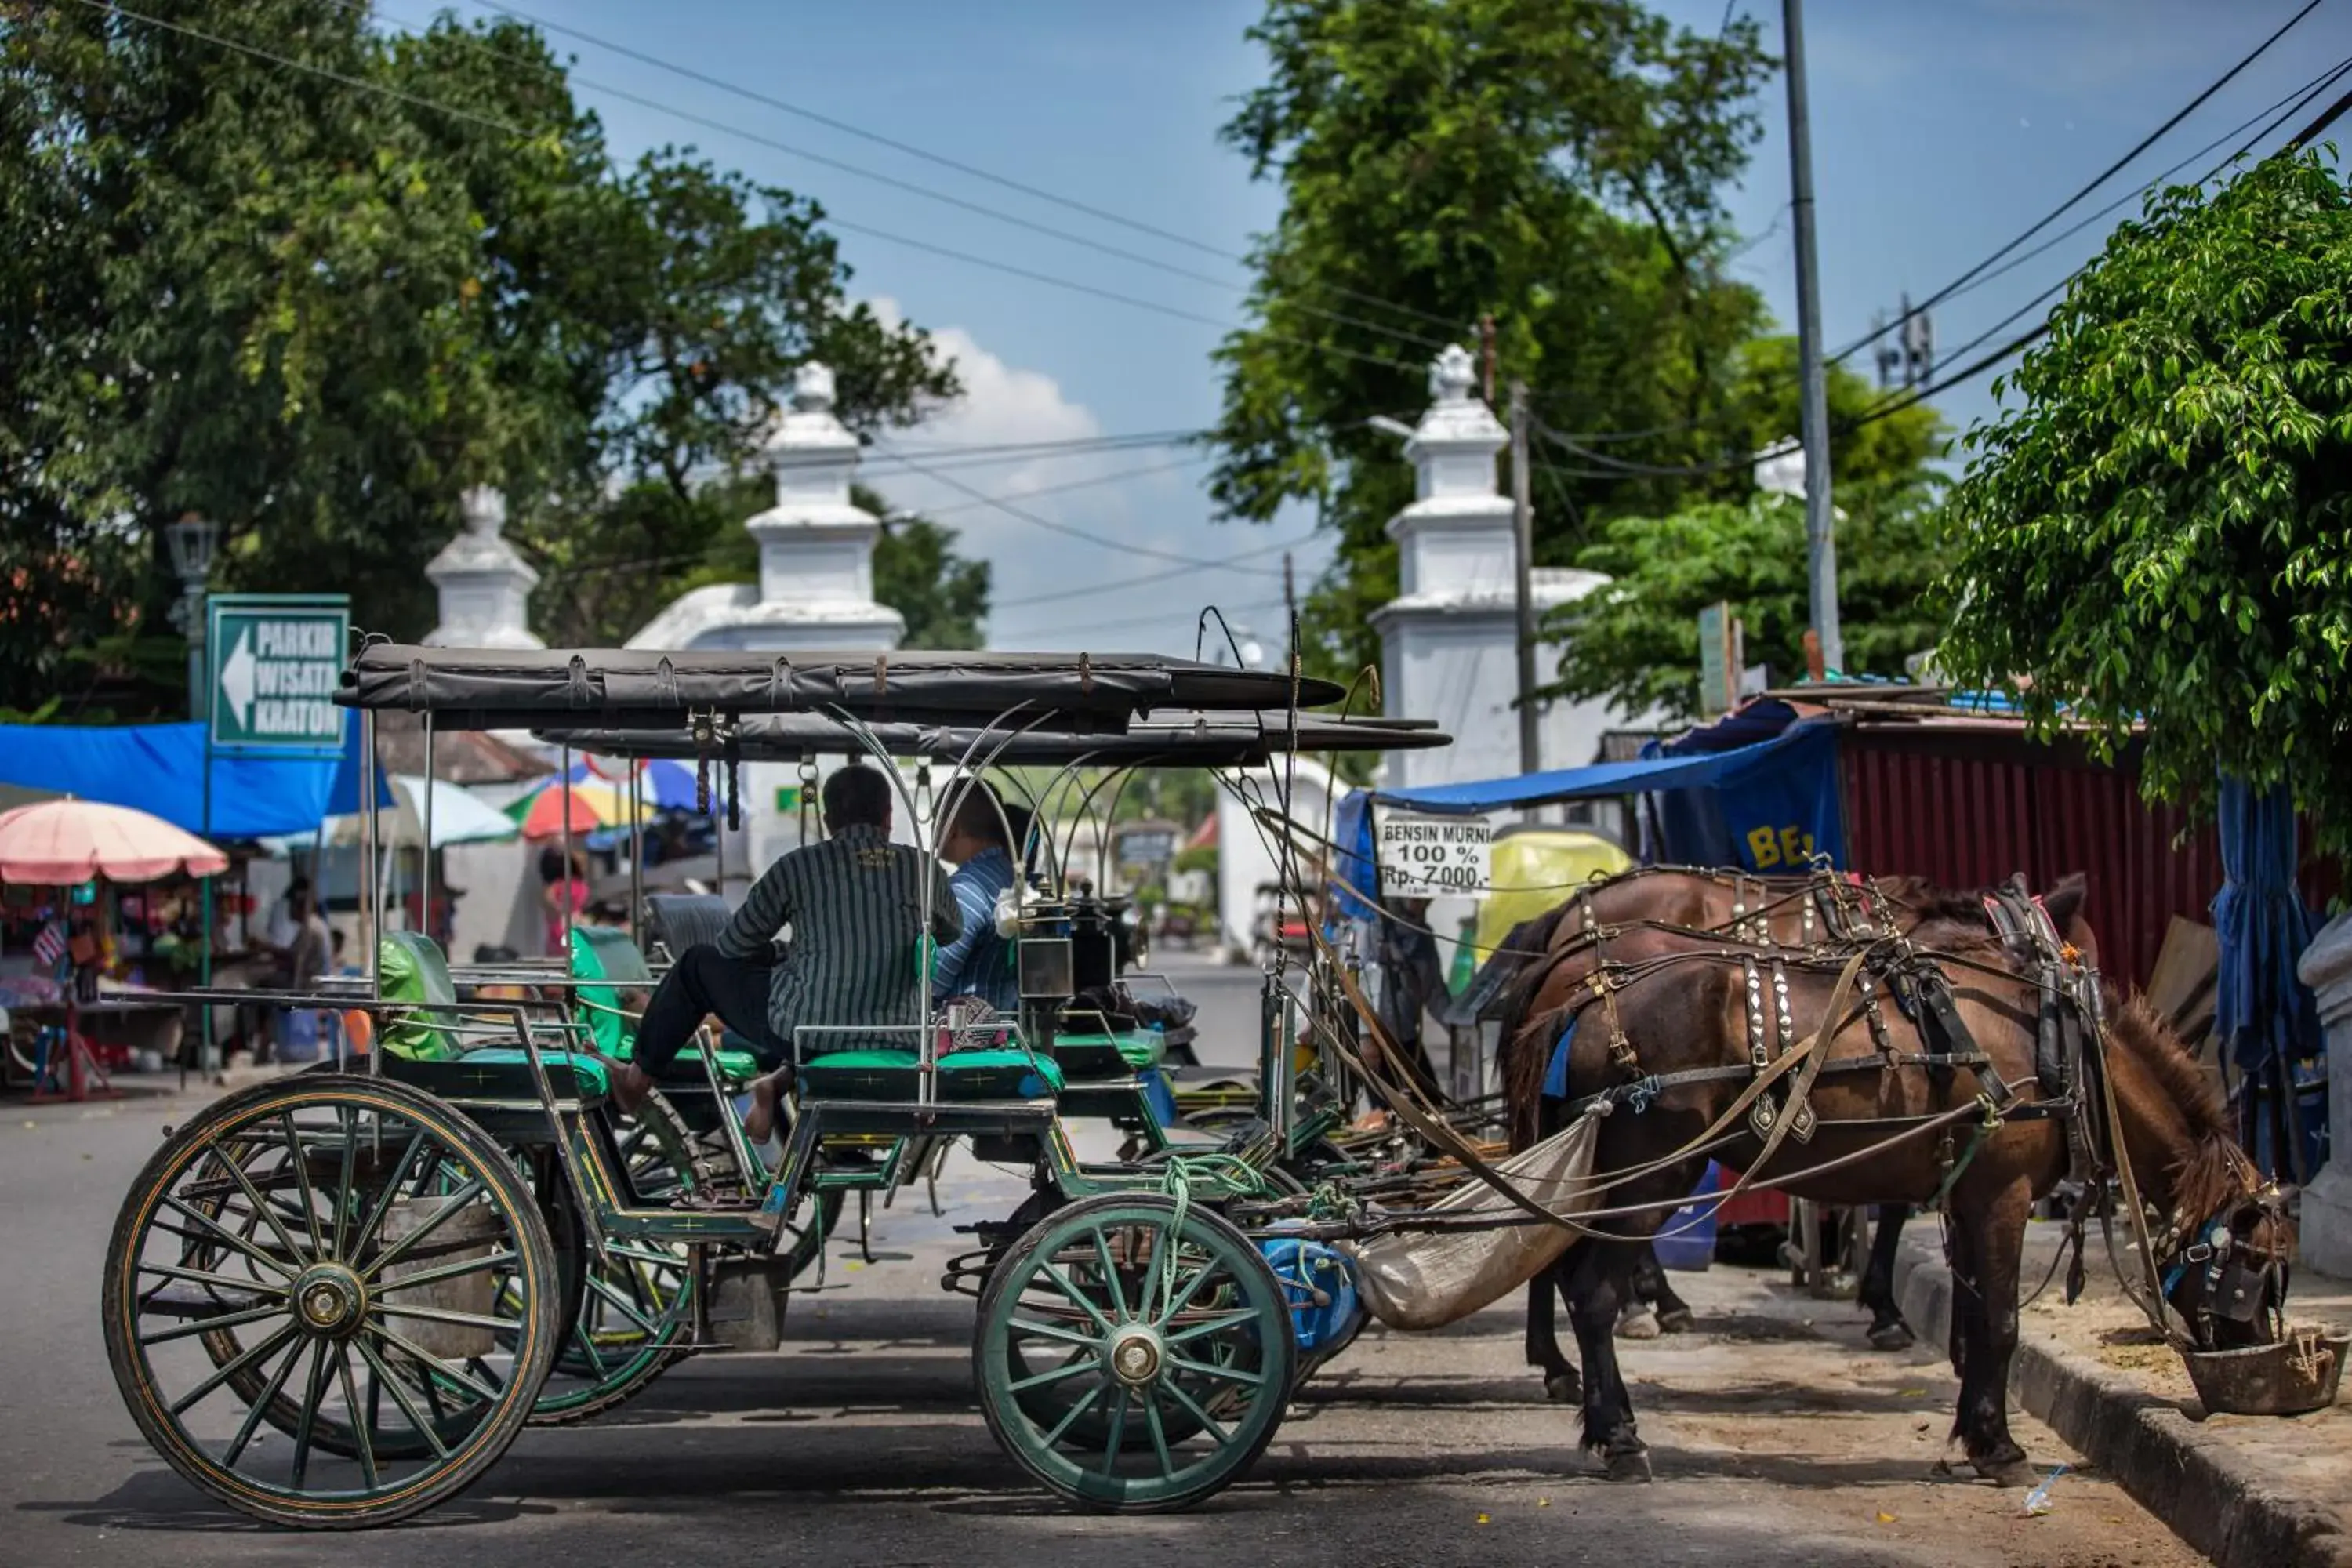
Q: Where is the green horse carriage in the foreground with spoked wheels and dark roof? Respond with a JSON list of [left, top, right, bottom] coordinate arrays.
[[103, 644, 1444, 1528]]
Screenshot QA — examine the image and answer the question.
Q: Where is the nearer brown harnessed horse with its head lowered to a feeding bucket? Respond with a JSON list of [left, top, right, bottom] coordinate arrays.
[[1503, 888, 2288, 1476]]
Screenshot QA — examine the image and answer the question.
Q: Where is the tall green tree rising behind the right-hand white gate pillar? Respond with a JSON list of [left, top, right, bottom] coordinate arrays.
[[1214, 0, 1778, 670]]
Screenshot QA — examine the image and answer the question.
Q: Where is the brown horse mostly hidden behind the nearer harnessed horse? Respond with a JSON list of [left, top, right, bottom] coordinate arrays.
[[1503, 865, 2098, 1403]]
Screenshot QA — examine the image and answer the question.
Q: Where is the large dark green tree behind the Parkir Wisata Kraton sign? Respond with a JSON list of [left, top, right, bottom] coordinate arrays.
[[0, 0, 955, 708]]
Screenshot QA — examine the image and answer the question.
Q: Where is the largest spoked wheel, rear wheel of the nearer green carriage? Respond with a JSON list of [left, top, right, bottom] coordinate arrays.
[[103, 1074, 562, 1530]]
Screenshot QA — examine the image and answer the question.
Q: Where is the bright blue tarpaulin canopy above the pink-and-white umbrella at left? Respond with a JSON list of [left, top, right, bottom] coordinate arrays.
[[0, 715, 393, 839]]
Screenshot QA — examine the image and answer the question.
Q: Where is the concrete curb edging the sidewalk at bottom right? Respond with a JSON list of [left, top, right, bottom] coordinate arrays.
[[1896, 1239, 2352, 1568]]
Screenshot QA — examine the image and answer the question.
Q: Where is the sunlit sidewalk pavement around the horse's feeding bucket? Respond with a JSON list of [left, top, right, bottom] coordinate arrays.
[[1896, 1220, 2352, 1568]]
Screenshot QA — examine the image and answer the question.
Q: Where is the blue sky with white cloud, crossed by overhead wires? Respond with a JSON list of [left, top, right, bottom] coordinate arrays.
[[423, 0, 2352, 652]]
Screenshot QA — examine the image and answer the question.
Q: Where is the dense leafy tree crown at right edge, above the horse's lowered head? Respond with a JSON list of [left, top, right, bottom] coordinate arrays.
[[1938, 153, 2352, 860]]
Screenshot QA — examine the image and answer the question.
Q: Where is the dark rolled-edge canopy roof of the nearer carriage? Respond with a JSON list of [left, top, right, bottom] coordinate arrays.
[[336, 644, 1345, 731]]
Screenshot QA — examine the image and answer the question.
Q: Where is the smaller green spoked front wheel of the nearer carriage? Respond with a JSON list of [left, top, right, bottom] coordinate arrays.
[[974, 1194, 1296, 1514]]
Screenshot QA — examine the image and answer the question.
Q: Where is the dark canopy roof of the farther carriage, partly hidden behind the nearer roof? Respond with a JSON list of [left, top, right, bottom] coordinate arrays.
[[536, 710, 1454, 769]]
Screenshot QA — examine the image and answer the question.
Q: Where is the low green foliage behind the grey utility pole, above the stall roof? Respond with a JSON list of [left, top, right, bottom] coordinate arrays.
[[1548, 480, 1940, 720]]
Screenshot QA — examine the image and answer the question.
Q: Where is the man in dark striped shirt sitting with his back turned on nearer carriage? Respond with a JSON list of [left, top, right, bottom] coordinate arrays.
[[612, 762, 964, 1142]]
